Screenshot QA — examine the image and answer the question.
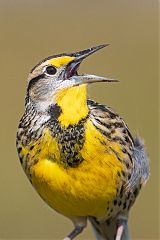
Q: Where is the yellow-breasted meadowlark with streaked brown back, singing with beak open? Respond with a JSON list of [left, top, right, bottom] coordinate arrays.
[[16, 44, 150, 240]]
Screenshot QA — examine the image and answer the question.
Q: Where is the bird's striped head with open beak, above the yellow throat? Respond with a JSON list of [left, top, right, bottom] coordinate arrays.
[[27, 45, 116, 111]]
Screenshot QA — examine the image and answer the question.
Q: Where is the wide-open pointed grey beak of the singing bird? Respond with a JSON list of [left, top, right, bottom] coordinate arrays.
[[64, 44, 118, 85]]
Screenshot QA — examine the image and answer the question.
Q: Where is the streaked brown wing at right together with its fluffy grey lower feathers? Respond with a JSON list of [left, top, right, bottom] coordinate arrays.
[[88, 100, 150, 192]]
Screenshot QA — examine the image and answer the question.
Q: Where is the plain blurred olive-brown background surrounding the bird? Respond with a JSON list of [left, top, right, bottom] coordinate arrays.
[[0, 0, 160, 240]]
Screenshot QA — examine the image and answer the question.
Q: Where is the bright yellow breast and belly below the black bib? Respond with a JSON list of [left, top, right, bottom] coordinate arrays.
[[30, 120, 123, 217]]
